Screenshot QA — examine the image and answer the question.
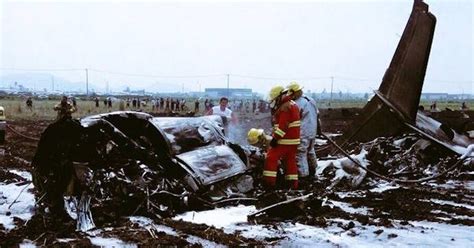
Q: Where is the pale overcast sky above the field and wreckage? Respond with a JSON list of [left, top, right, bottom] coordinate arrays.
[[0, 0, 474, 94]]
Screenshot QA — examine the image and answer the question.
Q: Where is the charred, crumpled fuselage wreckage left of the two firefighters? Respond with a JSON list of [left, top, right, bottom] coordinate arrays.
[[33, 114, 263, 230]]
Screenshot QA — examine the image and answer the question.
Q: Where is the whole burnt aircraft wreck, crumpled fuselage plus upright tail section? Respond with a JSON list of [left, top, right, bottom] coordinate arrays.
[[33, 0, 474, 230]]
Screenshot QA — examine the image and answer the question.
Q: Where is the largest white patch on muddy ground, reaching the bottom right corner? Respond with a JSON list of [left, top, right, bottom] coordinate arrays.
[[175, 204, 474, 247]]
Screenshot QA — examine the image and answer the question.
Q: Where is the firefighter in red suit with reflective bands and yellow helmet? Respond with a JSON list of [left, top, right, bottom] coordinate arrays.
[[263, 86, 300, 189]]
